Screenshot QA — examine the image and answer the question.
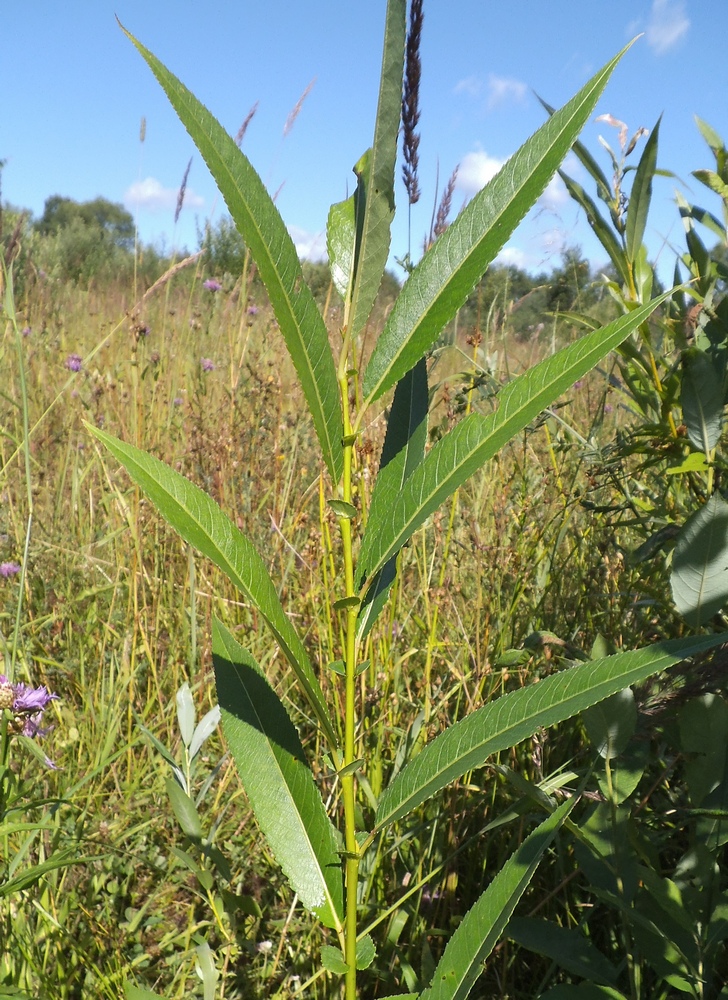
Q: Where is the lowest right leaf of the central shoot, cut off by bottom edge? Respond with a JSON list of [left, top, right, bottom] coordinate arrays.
[[420, 799, 576, 1000]]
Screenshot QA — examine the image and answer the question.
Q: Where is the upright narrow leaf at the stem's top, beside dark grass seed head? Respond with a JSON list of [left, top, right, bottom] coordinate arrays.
[[349, 0, 407, 336]]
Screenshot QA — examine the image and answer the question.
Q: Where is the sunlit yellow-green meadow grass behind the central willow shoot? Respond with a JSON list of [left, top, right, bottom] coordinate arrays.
[[0, 254, 712, 998]]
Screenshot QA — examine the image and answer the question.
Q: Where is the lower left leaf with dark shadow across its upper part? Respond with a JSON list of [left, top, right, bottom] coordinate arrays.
[[212, 619, 343, 930]]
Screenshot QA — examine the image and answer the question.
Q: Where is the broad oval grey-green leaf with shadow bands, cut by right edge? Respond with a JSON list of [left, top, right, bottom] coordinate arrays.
[[670, 493, 728, 628]]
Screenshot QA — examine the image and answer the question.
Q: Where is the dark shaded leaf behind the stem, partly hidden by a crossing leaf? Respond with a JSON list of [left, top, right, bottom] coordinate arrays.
[[357, 358, 429, 642]]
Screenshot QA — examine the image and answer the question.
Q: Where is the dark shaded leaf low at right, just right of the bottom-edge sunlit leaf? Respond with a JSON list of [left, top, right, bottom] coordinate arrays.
[[506, 917, 617, 986]]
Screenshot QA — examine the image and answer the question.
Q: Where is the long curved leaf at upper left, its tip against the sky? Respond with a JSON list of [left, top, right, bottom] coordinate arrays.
[[123, 28, 344, 483]]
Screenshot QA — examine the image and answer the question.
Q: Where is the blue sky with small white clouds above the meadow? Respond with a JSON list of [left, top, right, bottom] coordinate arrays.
[[5, 0, 728, 276]]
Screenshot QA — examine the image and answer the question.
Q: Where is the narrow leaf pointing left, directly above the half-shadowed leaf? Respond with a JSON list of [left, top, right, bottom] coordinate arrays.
[[86, 424, 338, 747]]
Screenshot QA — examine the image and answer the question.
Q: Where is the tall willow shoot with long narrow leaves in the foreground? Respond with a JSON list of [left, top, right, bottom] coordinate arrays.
[[92, 0, 718, 1000]]
